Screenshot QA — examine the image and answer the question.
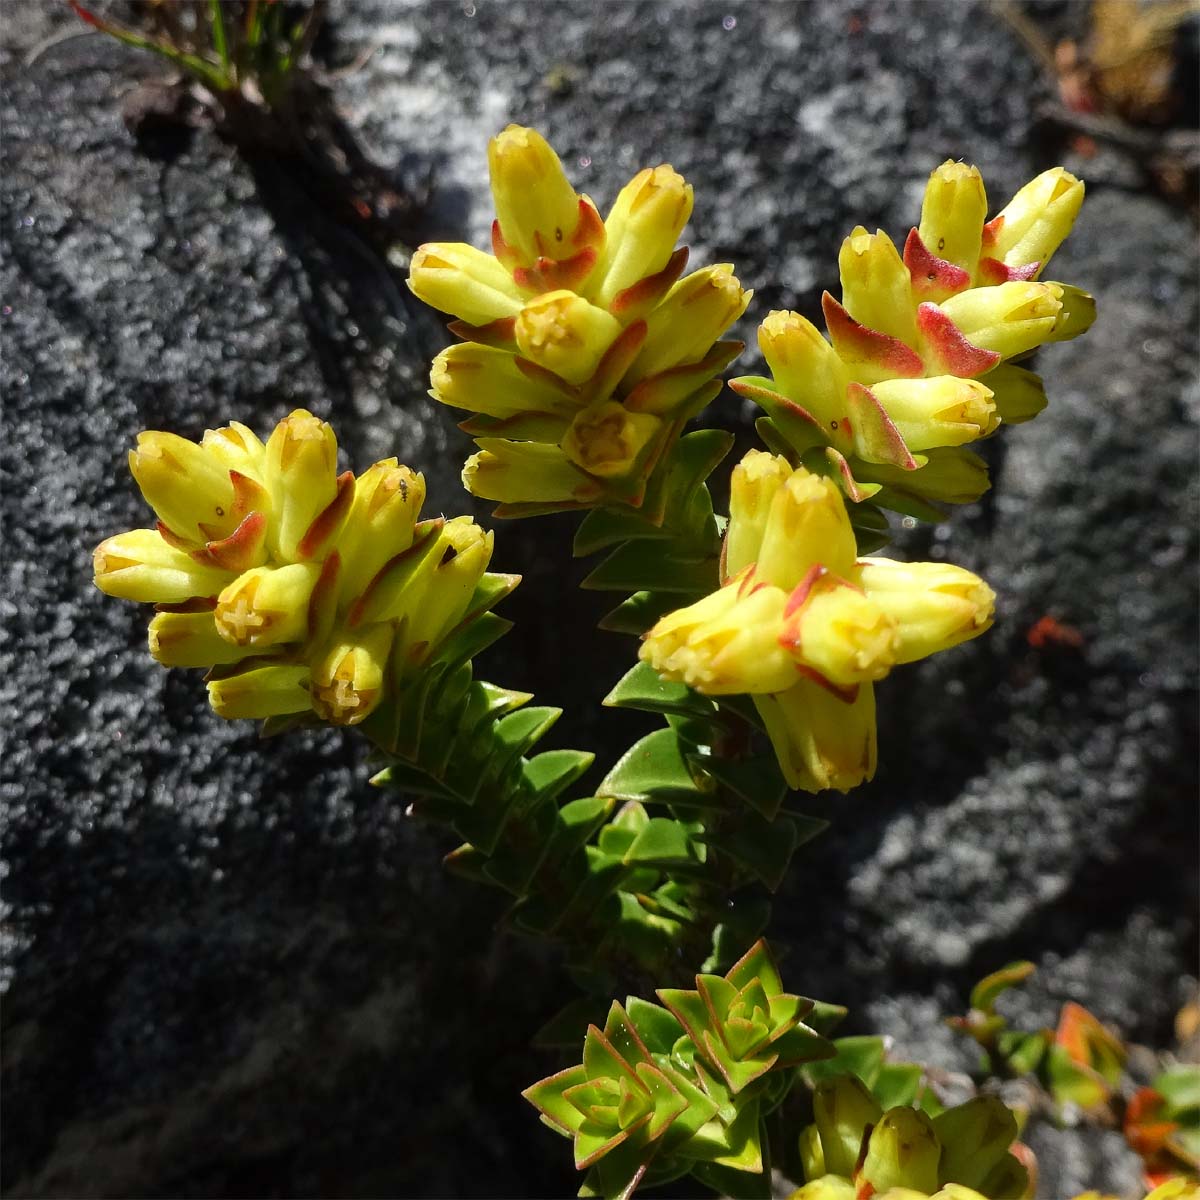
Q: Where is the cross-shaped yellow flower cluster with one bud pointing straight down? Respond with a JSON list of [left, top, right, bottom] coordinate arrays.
[[641, 450, 995, 792]]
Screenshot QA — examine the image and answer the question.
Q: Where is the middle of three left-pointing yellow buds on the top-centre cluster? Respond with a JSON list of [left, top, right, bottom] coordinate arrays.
[[430, 342, 578, 418]]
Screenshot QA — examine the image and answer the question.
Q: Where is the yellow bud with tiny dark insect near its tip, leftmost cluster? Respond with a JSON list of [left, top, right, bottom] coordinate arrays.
[[337, 458, 425, 599]]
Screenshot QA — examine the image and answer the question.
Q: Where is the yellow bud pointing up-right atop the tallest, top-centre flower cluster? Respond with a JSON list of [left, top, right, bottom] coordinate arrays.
[[589, 163, 692, 308]]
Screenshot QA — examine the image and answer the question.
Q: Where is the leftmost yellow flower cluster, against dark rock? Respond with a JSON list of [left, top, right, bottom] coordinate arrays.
[[95, 409, 492, 725]]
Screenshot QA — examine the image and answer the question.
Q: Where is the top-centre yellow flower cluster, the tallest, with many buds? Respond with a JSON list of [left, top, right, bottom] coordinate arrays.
[[408, 125, 750, 515]]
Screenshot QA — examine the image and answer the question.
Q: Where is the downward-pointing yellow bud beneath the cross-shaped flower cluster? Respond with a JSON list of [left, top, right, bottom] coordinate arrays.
[[754, 679, 877, 792]]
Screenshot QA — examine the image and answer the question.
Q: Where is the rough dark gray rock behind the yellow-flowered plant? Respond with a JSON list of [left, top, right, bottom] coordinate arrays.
[[0, 0, 1196, 1196]]
